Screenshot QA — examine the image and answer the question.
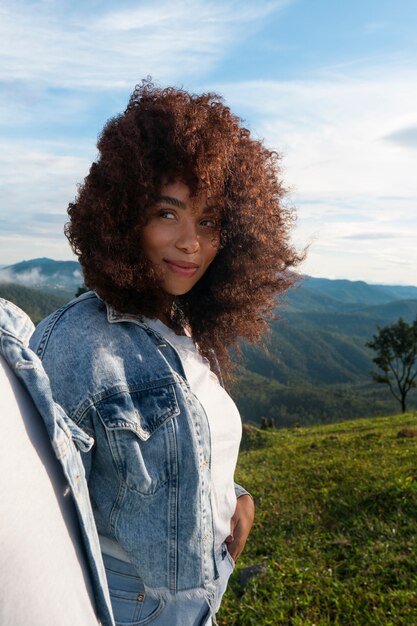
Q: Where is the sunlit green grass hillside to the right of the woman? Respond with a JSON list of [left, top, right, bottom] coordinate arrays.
[[218, 413, 417, 626]]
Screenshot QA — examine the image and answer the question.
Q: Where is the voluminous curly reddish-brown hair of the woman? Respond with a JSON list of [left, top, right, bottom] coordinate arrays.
[[65, 79, 301, 369]]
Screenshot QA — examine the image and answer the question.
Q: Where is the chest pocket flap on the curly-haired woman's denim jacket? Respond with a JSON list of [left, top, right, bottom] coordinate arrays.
[[96, 384, 180, 441]]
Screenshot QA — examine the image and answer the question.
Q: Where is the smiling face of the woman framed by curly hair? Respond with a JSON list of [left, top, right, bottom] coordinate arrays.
[[141, 182, 220, 296]]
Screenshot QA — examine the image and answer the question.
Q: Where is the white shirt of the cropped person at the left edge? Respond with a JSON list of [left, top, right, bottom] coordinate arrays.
[[0, 356, 97, 626]]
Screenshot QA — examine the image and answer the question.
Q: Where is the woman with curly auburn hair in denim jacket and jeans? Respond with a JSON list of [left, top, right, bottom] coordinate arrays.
[[32, 81, 299, 626]]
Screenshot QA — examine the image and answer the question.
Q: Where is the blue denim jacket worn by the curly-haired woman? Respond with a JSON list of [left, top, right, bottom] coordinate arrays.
[[31, 292, 247, 599]]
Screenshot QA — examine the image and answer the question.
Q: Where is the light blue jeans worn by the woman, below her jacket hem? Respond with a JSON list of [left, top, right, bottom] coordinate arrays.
[[103, 544, 234, 626]]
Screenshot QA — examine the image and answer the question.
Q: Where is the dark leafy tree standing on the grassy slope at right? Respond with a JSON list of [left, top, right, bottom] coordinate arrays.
[[366, 317, 417, 413]]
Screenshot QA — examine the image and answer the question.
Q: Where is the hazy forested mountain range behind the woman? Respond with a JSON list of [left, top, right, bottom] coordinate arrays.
[[0, 258, 417, 426]]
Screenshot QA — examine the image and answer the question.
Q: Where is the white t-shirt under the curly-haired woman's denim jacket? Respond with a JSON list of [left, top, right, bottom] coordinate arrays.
[[145, 319, 242, 549]]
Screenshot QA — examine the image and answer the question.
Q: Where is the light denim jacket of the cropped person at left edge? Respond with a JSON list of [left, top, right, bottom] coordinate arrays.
[[0, 298, 114, 626]]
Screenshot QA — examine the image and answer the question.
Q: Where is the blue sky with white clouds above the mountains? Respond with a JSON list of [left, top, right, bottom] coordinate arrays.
[[0, 0, 417, 285]]
